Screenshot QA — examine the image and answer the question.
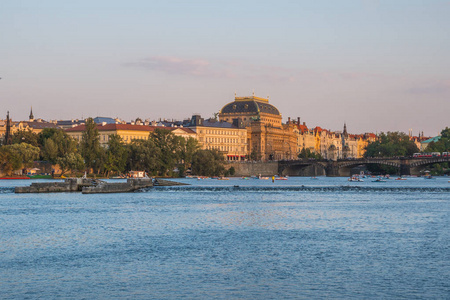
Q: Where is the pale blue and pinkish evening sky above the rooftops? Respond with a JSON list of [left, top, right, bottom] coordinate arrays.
[[0, 0, 450, 136]]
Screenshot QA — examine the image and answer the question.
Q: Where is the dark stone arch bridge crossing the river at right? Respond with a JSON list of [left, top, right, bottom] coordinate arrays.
[[278, 156, 450, 177]]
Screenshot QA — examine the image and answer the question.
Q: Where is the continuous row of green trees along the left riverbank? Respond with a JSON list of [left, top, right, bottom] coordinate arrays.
[[0, 118, 229, 177]]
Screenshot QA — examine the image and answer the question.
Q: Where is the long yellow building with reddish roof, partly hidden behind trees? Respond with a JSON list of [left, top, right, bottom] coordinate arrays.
[[65, 124, 197, 146]]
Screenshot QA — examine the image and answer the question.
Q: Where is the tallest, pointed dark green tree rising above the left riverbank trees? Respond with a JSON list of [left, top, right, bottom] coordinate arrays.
[[80, 118, 104, 173]]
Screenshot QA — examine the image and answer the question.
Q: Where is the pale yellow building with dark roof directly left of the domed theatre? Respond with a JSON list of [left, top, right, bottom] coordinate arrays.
[[189, 115, 247, 161]]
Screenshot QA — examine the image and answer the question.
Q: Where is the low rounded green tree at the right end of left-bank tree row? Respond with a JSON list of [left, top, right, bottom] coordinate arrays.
[[192, 149, 225, 176]]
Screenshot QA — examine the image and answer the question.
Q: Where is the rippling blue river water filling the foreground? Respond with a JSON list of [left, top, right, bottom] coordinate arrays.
[[0, 177, 450, 299]]
